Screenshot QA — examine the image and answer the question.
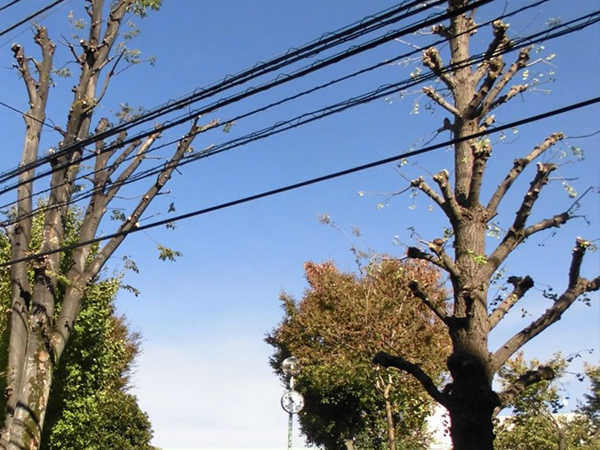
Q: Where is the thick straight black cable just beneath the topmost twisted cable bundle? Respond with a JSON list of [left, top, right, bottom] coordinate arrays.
[[0, 0, 493, 195]]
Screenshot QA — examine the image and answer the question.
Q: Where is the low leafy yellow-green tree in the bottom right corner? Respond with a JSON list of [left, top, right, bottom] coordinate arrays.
[[495, 354, 600, 450]]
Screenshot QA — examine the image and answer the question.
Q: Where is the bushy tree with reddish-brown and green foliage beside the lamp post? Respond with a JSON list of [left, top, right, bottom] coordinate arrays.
[[266, 258, 448, 450]]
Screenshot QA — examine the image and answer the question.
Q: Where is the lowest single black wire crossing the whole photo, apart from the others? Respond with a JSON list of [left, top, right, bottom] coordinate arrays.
[[0, 97, 600, 267]]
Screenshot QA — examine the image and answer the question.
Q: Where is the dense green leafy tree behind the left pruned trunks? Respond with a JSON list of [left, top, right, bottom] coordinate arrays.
[[0, 210, 153, 450]]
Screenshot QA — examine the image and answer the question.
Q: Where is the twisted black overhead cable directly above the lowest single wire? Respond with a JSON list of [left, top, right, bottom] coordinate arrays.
[[0, 7, 600, 226]]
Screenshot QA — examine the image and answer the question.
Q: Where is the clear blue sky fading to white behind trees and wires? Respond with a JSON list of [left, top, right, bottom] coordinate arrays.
[[0, 0, 600, 448]]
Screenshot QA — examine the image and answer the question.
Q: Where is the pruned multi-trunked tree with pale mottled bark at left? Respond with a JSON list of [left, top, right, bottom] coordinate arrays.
[[0, 0, 207, 450]]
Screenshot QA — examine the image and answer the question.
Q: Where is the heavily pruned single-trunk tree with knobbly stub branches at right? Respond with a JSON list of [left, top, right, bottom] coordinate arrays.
[[374, 0, 600, 450]]
